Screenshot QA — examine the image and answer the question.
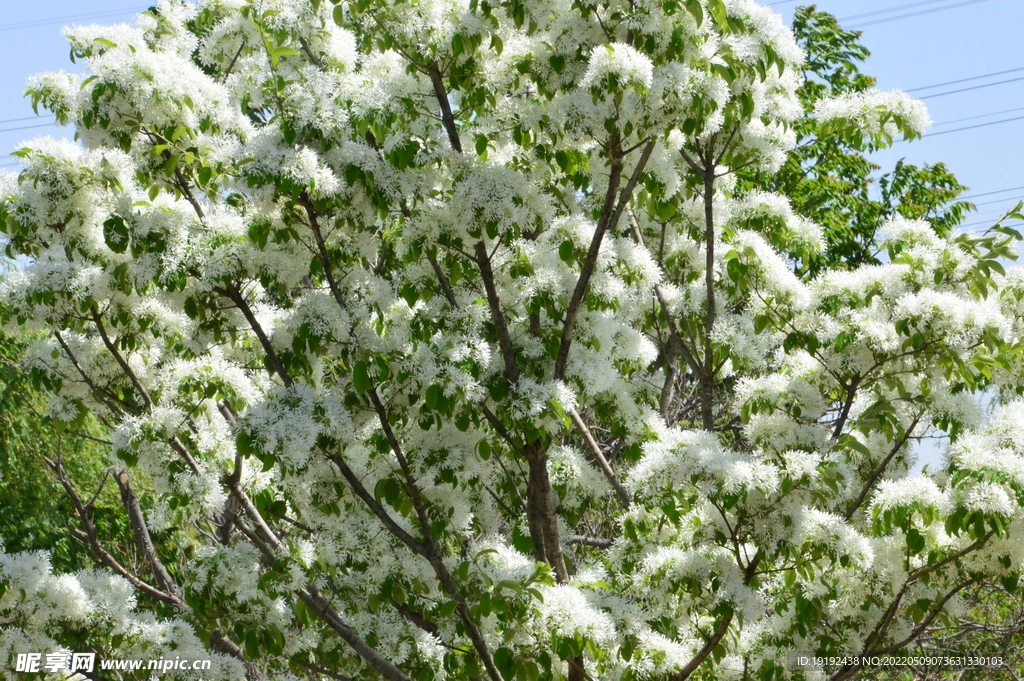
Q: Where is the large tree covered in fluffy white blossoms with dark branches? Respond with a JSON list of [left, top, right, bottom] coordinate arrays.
[[0, 0, 1024, 681]]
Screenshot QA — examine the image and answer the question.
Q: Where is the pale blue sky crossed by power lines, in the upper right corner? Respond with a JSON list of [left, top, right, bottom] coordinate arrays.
[[769, 0, 1024, 228]]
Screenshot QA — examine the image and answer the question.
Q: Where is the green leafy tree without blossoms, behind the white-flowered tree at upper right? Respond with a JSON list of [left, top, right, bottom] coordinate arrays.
[[742, 5, 974, 276]]
